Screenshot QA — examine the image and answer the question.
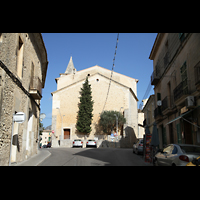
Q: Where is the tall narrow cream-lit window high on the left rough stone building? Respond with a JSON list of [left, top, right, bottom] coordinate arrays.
[[17, 36, 24, 78]]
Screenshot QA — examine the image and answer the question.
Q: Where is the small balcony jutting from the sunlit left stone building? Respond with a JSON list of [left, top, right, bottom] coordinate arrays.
[[29, 76, 42, 100]]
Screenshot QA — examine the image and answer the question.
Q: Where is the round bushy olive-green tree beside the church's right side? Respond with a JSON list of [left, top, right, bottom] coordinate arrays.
[[100, 110, 126, 134]]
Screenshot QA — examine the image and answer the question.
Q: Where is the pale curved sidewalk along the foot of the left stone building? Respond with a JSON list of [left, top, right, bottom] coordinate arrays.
[[11, 149, 51, 166]]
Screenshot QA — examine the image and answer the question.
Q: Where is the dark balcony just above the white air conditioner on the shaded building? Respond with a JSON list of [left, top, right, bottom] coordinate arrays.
[[174, 81, 189, 104]]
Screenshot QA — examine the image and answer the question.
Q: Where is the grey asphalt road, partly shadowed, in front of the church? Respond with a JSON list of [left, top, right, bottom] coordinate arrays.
[[39, 148, 152, 166]]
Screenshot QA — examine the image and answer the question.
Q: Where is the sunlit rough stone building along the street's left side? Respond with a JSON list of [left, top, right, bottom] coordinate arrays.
[[0, 33, 48, 165]]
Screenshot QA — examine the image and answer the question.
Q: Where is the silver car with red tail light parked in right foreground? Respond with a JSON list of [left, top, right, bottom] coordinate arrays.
[[154, 144, 200, 166]]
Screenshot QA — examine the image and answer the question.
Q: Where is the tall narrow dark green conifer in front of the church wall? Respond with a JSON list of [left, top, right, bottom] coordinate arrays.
[[76, 77, 94, 134]]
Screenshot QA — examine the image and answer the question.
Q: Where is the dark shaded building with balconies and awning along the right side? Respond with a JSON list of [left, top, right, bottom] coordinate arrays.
[[149, 33, 200, 148]]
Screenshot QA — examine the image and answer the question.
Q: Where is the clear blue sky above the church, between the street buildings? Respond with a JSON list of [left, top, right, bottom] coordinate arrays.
[[41, 33, 157, 127]]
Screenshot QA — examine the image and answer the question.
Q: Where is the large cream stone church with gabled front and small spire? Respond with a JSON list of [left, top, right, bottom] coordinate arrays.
[[52, 57, 138, 147]]
